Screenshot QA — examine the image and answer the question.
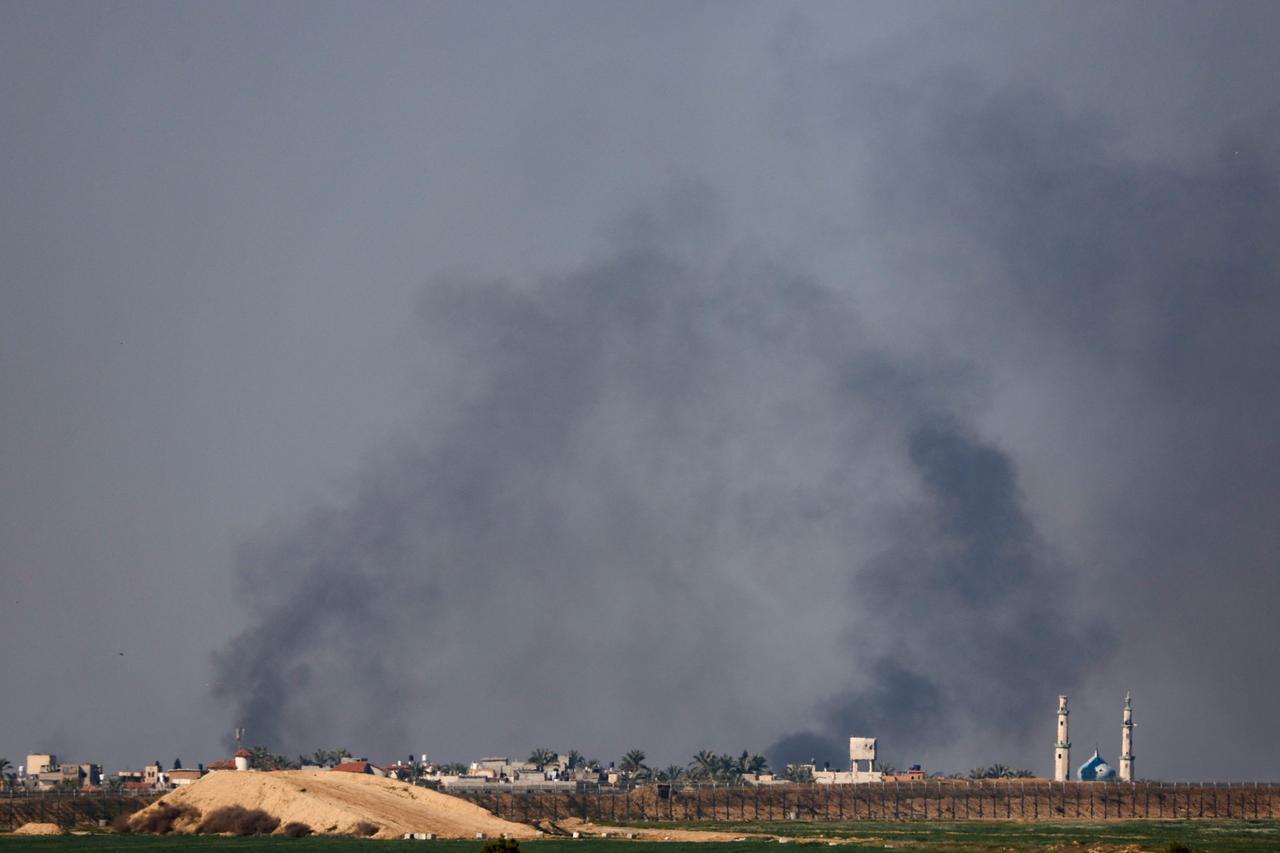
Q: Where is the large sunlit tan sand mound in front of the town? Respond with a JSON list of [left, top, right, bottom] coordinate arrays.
[[131, 770, 538, 839]]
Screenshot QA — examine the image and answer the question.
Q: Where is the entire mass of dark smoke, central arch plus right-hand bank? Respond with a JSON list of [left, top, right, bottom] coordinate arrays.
[[218, 69, 1280, 766]]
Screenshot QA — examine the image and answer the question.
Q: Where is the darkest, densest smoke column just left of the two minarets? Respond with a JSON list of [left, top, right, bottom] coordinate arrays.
[[771, 419, 1111, 767]]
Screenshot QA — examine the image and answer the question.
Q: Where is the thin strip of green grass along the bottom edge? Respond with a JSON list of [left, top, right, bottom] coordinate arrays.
[[0, 821, 1280, 853]]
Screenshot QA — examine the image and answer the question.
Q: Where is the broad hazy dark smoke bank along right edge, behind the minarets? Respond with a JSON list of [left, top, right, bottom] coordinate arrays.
[[828, 74, 1280, 775]]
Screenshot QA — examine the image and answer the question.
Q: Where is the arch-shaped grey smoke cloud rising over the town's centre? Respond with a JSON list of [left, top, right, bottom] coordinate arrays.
[[218, 179, 1088, 760]]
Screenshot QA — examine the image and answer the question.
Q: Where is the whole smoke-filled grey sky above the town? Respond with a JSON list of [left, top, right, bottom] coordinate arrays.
[[0, 3, 1280, 777]]
